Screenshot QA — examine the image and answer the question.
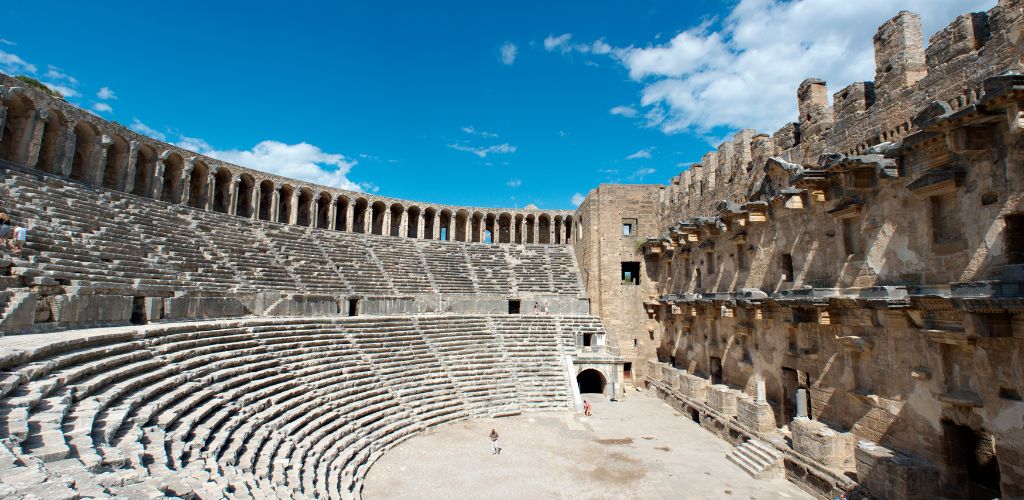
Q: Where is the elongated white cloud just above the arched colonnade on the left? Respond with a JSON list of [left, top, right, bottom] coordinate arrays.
[[176, 137, 366, 191]]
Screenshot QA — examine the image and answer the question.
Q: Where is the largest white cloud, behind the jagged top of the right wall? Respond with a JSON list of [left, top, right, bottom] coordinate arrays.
[[545, 0, 995, 134]]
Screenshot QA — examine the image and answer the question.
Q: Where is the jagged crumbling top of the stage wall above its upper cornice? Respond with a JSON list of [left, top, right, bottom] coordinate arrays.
[[664, 0, 1024, 220]]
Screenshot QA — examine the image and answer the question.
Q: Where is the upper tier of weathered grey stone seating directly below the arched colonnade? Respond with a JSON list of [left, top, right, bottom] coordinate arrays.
[[0, 165, 584, 296]]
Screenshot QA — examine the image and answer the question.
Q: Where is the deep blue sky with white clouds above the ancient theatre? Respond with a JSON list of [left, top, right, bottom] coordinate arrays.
[[0, 0, 994, 209]]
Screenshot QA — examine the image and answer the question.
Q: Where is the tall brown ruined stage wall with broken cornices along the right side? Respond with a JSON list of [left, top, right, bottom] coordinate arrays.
[[644, 0, 1024, 498]]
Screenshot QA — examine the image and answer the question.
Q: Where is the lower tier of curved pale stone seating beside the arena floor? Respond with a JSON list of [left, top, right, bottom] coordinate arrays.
[[0, 315, 602, 498]]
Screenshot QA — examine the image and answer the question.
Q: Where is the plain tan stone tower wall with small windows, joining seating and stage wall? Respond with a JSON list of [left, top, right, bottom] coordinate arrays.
[[574, 184, 665, 379]]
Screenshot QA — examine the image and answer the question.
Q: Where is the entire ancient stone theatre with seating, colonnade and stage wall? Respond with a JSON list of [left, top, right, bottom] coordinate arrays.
[[0, 0, 1024, 499]]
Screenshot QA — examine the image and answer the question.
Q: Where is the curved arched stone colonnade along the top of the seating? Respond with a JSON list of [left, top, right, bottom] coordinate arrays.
[[0, 87, 573, 244]]
